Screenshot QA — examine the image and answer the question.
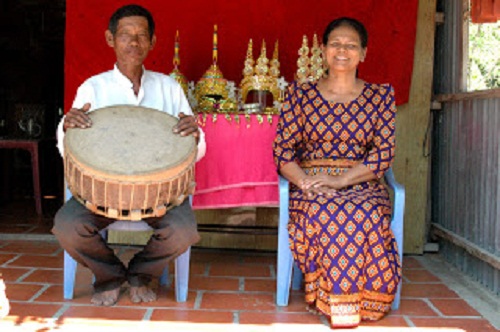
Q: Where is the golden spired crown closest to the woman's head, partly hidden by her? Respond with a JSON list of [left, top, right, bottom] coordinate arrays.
[[295, 34, 325, 83]]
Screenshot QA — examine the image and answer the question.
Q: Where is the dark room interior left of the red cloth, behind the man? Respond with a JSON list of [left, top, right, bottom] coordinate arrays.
[[0, 0, 66, 233]]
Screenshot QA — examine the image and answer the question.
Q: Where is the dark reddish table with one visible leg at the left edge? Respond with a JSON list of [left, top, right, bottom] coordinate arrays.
[[0, 139, 42, 216]]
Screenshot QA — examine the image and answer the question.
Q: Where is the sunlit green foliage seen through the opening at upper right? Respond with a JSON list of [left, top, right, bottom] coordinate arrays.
[[467, 22, 500, 91]]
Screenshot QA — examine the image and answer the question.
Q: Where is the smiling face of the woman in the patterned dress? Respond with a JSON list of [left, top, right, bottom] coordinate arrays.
[[322, 25, 367, 73]]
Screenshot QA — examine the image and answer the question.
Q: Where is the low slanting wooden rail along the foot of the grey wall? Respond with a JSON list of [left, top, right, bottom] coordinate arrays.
[[431, 223, 500, 270]]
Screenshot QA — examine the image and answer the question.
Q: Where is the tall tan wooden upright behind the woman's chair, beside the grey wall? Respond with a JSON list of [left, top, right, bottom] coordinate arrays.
[[394, 0, 436, 254]]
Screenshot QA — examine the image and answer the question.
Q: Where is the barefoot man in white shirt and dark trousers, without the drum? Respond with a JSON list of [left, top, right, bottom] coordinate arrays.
[[52, 5, 206, 306]]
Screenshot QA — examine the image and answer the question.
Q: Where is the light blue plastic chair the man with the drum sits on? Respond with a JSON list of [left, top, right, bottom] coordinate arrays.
[[63, 189, 191, 302]]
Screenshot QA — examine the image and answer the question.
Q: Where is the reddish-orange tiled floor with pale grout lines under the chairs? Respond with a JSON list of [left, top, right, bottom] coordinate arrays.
[[0, 198, 497, 332]]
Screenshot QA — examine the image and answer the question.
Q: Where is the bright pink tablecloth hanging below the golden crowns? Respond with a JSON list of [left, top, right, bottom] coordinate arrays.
[[193, 114, 279, 209]]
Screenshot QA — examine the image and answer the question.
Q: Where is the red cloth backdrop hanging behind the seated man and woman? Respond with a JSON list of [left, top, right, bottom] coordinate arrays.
[[65, 0, 418, 111]]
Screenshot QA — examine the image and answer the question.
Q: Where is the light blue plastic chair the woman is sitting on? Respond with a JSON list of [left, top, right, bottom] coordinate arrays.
[[276, 168, 405, 310]]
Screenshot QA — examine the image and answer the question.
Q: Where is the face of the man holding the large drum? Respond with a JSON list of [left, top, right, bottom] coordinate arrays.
[[106, 16, 156, 66]]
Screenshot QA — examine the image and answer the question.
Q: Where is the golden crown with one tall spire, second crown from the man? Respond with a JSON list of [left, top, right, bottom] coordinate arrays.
[[194, 25, 238, 112]]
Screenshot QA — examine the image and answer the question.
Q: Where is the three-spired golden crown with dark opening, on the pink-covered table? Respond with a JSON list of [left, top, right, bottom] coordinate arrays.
[[240, 39, 280, 107]]
